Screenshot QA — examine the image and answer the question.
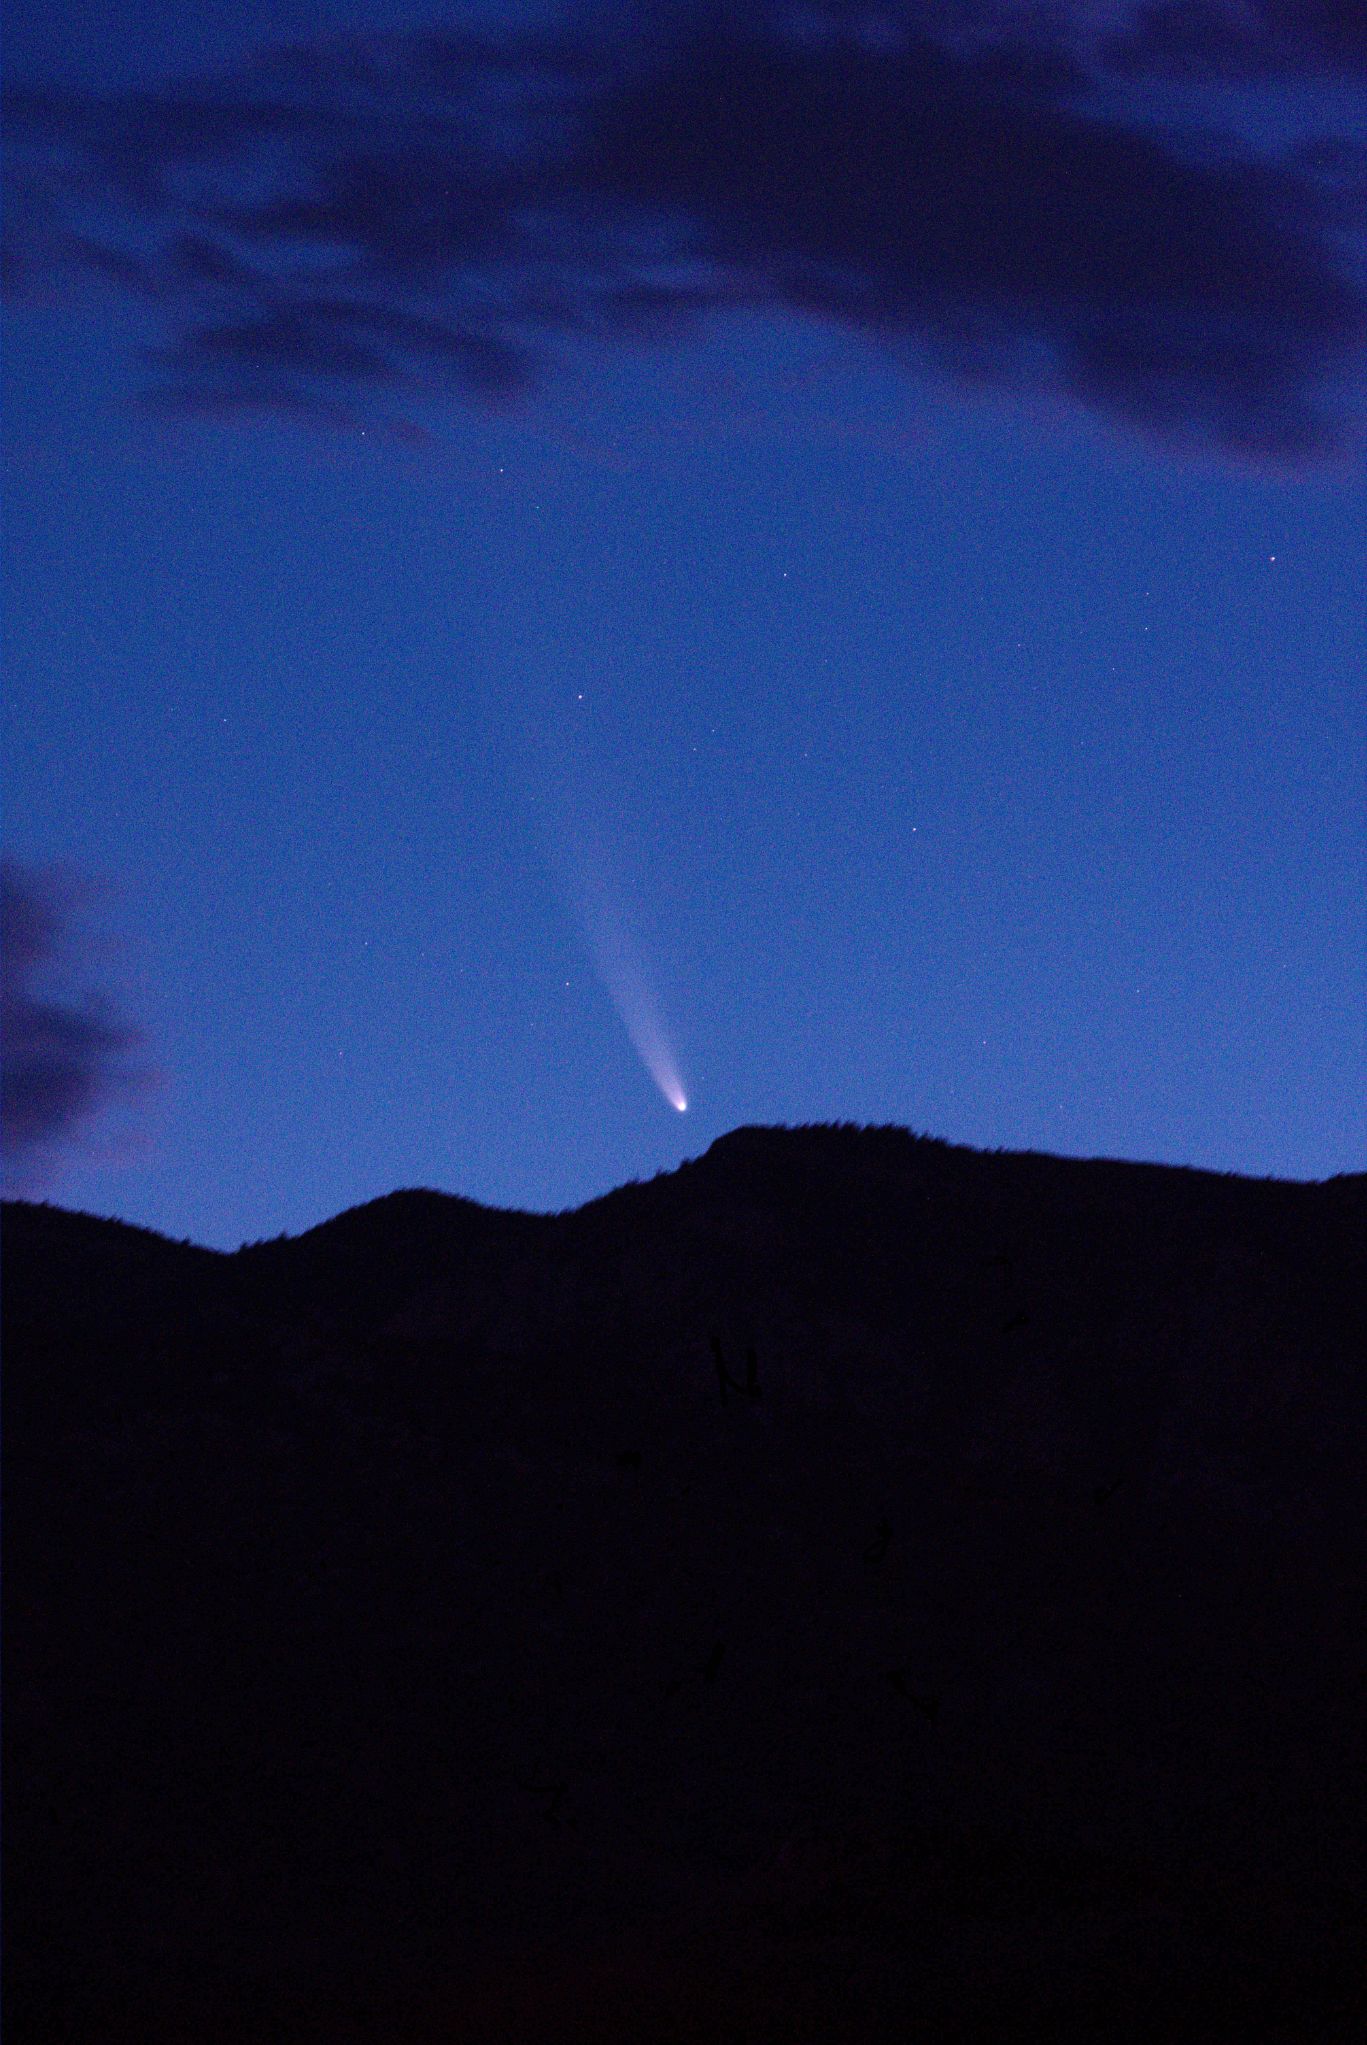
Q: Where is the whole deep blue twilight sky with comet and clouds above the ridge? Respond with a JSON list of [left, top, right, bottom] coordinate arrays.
[[4, 0, 1367, 1247]]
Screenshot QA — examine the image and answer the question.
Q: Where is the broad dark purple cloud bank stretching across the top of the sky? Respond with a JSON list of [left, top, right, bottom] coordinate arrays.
[[10, 0, 1367, 458]]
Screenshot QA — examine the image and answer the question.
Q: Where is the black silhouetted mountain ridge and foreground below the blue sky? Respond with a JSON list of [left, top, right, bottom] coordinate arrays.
[[4, 1129, 1367, 2045]]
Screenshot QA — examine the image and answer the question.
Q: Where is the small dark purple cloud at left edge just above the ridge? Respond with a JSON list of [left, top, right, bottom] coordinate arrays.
[[0, 859, 143, 1190]]
